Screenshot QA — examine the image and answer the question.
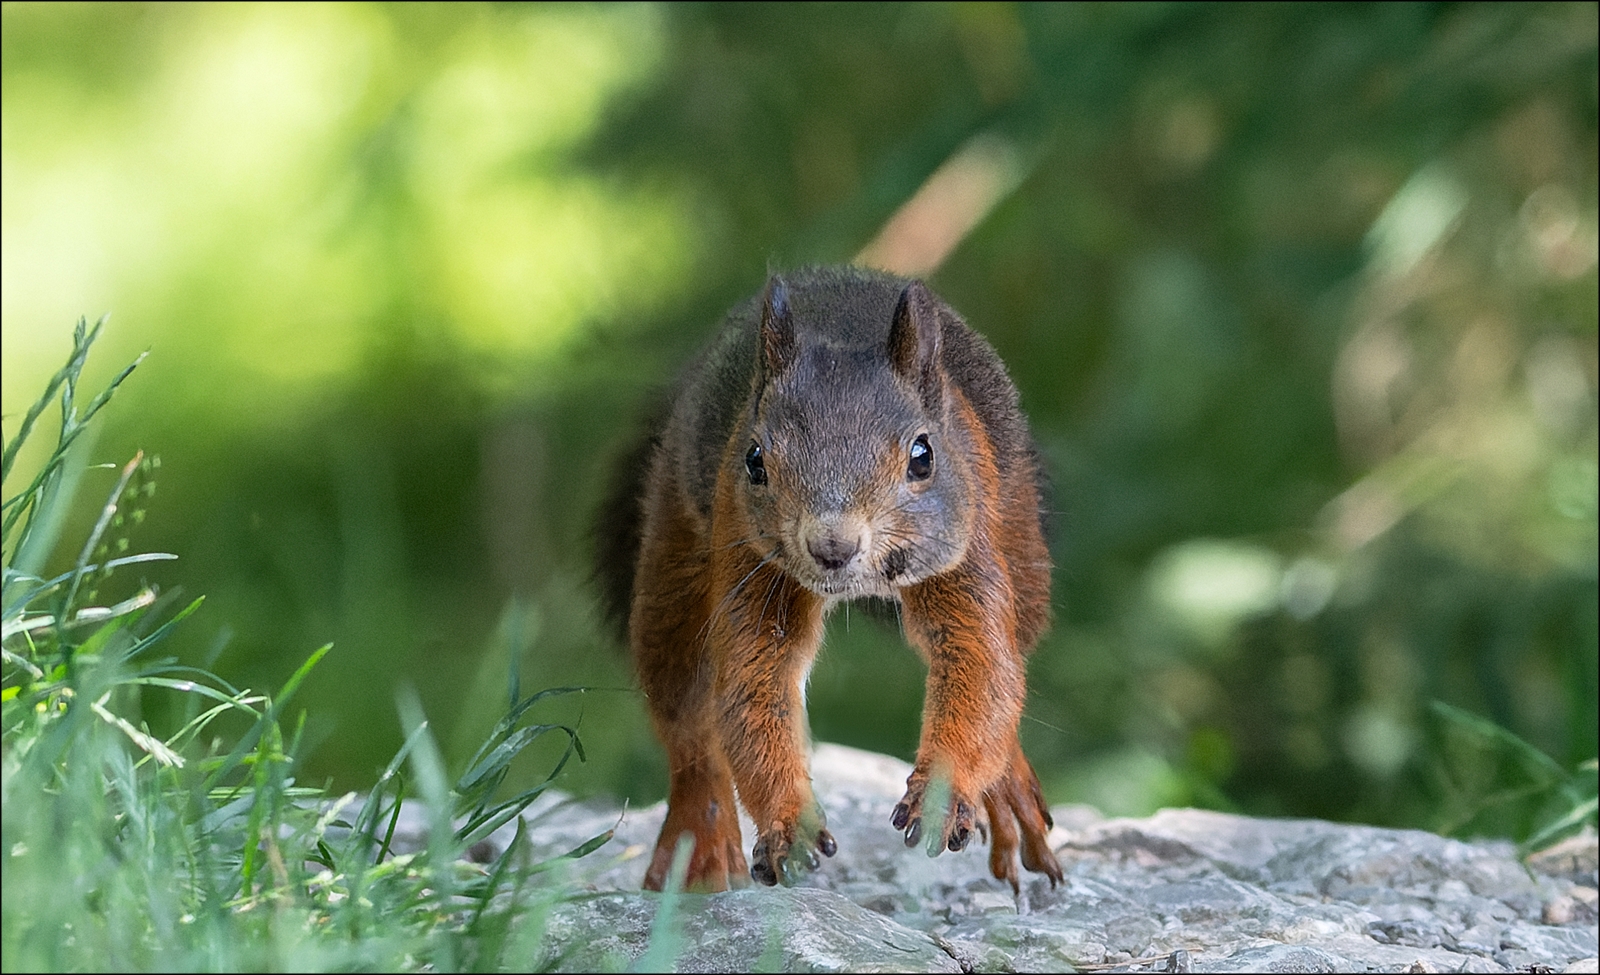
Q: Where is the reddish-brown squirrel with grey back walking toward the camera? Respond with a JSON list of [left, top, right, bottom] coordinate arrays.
[[597, 267, 1062, 892]]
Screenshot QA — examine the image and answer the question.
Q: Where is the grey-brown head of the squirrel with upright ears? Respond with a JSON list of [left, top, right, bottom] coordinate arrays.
[[730, 277, 974, 599]]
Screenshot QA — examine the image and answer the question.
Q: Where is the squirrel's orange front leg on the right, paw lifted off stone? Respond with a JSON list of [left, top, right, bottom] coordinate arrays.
[[891, 551, 1026, 853]]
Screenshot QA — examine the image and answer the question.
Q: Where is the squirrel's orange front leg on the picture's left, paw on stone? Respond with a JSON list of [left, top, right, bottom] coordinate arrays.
[[712, 553, 837, 885]]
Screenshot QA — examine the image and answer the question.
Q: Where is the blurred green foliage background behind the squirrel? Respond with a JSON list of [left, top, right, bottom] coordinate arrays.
[[0, 3, 1600, 836]]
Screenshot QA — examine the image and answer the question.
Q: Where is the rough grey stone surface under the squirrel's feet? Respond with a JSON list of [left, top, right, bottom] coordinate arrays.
[[393, 744, 1600, 972]]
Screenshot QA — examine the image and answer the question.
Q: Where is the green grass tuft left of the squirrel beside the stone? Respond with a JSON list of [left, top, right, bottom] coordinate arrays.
[[0, 322, 610, 972]]
